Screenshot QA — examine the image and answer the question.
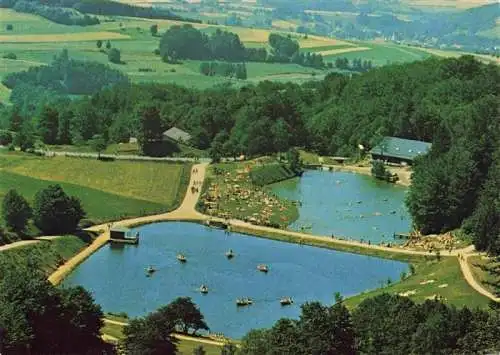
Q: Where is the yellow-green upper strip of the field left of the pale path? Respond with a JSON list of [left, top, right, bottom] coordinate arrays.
[[0, 155, 189, 207]]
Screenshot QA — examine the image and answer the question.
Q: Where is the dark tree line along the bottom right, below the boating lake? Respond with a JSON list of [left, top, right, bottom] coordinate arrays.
[[240, 294, 500, 355]]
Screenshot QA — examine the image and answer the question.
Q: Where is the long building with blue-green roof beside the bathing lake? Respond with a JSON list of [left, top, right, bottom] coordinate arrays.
[[370, 137, 432, 165]]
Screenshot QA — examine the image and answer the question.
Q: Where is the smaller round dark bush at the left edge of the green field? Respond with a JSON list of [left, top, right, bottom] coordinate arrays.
[[2, 190, 32, 234]]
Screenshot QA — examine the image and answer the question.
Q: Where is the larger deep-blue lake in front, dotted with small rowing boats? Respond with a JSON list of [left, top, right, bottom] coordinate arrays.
[[63, 222, 408, 338]]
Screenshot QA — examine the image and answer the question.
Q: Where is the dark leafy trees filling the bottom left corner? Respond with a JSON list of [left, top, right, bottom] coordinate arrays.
[[0, 262, 113, 354]]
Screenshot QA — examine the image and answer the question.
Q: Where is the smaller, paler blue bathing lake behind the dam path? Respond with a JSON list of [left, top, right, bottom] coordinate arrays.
[[271, 170, 411, 244]]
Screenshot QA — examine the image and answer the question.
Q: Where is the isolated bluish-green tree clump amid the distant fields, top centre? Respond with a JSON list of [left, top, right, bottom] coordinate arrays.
[[160, 25, 325, 68]]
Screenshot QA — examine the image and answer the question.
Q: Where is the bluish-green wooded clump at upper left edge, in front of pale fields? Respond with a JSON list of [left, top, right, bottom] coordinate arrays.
[[2, 50, 128, 94]]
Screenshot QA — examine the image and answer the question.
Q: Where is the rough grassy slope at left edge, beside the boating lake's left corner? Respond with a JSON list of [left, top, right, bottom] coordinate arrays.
[[0, 236, 88, 277]]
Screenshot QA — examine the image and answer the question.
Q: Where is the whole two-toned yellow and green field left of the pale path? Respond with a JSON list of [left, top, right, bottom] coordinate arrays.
[[0, 154, 190, 222]]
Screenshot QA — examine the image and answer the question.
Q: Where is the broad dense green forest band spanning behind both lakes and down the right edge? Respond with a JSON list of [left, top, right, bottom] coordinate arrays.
[[0, 56, 500, 254]]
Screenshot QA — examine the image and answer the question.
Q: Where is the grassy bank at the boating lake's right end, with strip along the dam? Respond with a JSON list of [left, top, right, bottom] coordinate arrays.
[[228, 227, 489, 308]]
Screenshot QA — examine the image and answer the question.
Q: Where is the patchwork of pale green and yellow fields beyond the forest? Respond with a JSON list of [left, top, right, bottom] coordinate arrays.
[[0, 9, 486, 95]]
